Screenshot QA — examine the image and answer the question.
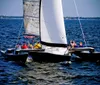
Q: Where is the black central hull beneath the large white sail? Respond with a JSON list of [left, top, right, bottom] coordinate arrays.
[[29, 51, 71, 63]]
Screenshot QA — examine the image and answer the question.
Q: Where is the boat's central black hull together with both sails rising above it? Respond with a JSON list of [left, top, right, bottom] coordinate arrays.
[[24, 0, 71, 62]]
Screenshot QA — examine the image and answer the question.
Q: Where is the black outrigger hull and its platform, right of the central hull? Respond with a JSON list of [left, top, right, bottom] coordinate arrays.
[[70, 47, 100, 61]]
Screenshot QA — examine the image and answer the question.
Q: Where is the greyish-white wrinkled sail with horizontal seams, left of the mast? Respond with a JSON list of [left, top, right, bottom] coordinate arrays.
[[23, 0, 40, 35]]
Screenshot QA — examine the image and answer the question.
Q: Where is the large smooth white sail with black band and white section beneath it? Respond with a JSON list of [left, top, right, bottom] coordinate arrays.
[[40, 0, 68, 55]]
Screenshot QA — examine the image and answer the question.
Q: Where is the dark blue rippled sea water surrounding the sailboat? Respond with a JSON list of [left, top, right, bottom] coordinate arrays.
[[0, 19, 100, 85]]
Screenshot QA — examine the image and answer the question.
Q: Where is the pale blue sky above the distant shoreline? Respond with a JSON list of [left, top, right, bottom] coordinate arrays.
[[0, 0, 100, 17]]
